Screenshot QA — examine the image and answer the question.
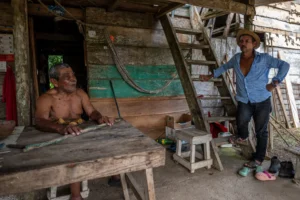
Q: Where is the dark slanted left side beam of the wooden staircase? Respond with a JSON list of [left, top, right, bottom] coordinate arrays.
[[160, 15, 208, 130]]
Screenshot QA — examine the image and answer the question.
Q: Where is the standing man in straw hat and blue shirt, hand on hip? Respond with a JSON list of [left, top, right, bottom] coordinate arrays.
[[200, 29, 290, 168]]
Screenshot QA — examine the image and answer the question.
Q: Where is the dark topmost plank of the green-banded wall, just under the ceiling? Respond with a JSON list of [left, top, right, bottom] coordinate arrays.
[[86, 7, 161, 29]]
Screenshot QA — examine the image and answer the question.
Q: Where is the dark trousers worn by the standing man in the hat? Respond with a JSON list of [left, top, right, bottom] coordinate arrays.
[[236, 97, 272, 162]]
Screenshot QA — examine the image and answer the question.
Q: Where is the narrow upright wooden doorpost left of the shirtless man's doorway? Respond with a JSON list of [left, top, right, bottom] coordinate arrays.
[[29, 17, 40, 101]]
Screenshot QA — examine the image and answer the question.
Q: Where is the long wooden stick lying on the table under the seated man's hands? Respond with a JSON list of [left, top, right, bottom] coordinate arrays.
[[23, 120, 120, 152]]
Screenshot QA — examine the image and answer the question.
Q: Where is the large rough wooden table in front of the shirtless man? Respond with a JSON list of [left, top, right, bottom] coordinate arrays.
[[0, 121, 165, 200]]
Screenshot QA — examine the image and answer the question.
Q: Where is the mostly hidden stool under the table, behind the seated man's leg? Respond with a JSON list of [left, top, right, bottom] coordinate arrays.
[[47, 181, 90, 200]]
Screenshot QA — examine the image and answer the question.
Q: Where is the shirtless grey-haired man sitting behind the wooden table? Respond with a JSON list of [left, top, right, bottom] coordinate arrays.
[[35, 64, 114, 200]]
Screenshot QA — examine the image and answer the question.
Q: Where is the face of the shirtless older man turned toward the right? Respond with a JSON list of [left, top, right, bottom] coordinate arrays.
[[55, 67, 77, 93]]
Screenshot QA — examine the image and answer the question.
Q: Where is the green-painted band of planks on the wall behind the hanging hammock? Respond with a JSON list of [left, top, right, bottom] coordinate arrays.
[[88, 65, 184, 98]]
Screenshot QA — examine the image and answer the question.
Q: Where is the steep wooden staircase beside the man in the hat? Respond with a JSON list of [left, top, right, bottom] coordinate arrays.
[[160, 6, 254, 170]]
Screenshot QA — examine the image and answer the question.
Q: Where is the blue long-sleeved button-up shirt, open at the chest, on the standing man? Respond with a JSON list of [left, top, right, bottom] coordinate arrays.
[[214, 51, 290, 103]]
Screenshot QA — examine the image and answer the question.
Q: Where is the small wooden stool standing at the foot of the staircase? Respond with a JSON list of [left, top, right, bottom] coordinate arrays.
[[173, 128, 213, 173]]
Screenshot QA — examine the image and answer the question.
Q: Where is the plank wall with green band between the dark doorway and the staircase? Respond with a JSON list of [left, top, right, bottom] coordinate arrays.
[[86, 8, 189, 138]]
